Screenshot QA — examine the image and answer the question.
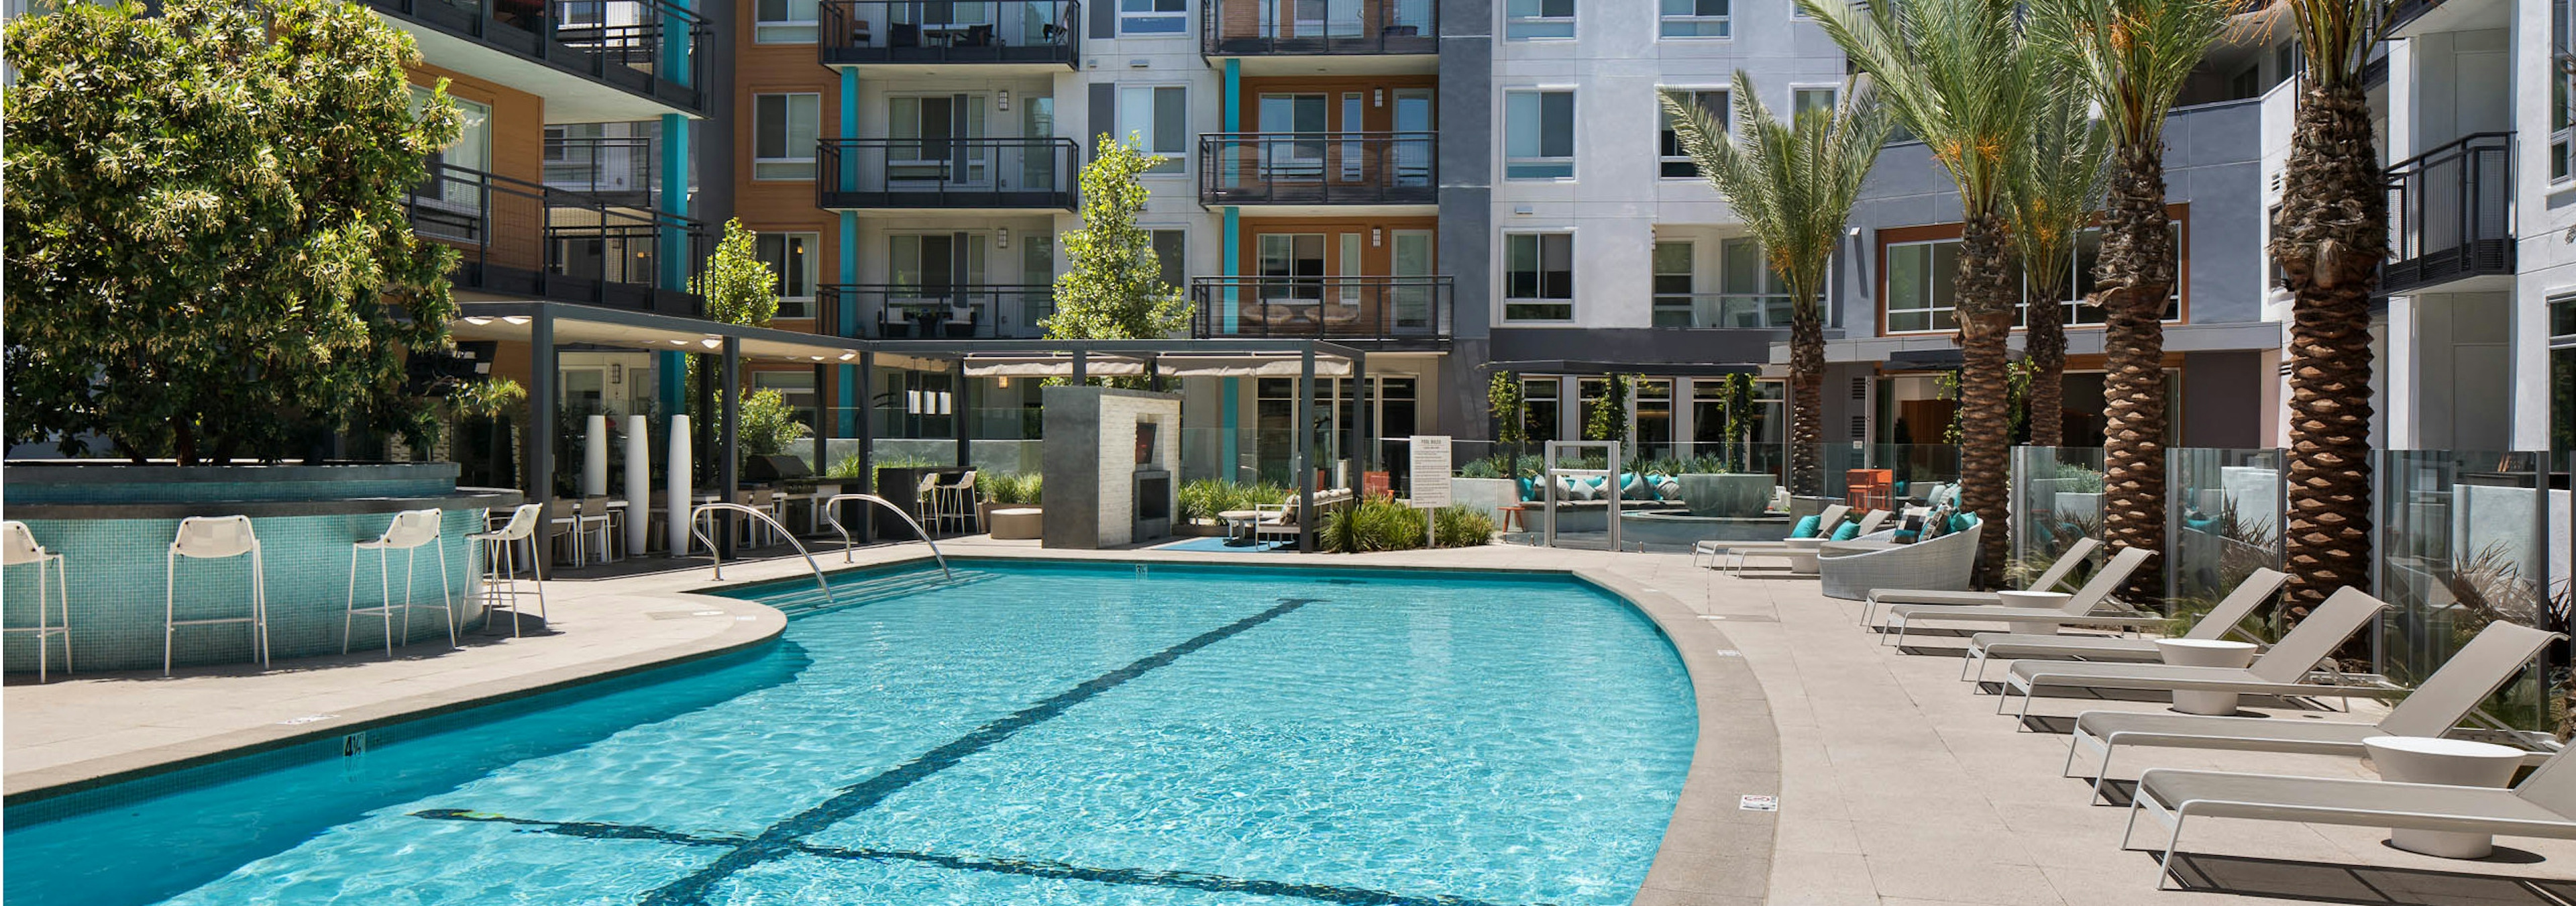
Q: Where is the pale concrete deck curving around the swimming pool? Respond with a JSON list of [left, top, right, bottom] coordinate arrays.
[[0, 538, 2576, 906]]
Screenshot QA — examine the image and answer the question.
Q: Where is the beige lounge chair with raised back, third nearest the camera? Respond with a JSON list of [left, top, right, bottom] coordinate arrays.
[[1994, 587, 2401, 723]]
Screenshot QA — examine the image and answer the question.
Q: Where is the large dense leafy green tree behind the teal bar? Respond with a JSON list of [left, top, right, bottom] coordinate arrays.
[[0, 0, 461, 463]]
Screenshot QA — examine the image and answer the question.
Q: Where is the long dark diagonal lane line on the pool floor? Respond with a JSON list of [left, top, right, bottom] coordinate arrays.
[[628, 597, 1319, 906]]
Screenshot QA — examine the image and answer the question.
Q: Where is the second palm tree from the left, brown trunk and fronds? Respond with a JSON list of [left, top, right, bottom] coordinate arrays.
[[1798, 0, 2045, 587]]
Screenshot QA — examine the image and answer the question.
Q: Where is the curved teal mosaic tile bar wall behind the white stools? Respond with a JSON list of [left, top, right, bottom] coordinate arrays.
[[0, 509, 484, 674]]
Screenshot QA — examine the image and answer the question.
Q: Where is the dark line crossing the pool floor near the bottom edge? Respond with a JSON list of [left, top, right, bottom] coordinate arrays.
[[412, 808, 1535, 906]]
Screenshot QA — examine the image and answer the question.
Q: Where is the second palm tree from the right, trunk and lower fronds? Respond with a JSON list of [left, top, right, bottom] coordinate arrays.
[[2033, 0, 2229, 600]]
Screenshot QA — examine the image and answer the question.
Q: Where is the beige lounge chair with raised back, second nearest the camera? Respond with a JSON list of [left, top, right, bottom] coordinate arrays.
[[2058, 623, 2561, 798]]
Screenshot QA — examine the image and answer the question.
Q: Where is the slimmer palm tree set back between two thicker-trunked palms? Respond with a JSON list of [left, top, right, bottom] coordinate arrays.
[[2004, 90, 2110, 448]]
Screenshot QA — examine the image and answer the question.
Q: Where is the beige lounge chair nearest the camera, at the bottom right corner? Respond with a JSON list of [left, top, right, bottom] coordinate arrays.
[[2120, 752, 2576, 891]]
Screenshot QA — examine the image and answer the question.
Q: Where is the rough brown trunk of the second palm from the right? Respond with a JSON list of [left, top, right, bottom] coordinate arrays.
[[2100, 144, 2174, 605]]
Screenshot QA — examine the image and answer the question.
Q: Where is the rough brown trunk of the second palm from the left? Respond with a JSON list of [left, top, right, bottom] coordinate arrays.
[[1957, 213, 2020, 587]]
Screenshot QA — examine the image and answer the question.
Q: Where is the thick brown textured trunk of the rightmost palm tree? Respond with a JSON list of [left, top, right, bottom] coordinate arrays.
[[2272, 83, 2388, 630]]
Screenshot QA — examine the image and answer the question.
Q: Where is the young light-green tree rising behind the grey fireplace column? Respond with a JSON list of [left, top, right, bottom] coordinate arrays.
[[1043, 134, 1190, 340]]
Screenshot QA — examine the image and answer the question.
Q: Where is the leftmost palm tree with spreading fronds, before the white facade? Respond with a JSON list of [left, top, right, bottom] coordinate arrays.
[[1662, 70, 1888, 494]]
